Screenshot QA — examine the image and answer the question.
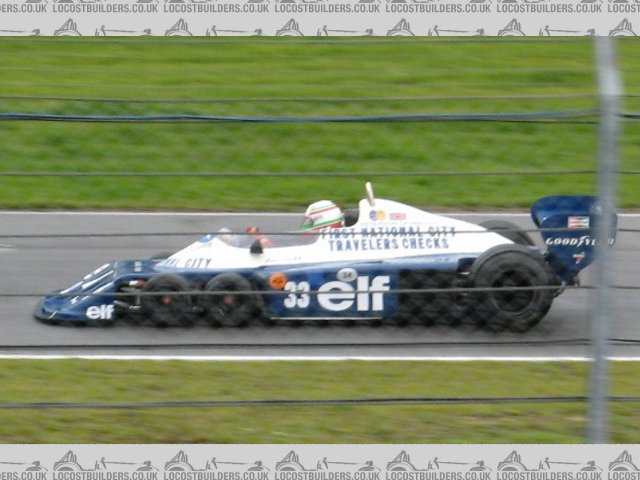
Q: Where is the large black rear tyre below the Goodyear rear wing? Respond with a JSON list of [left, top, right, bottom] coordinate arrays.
[[471, 245, 553, 332]]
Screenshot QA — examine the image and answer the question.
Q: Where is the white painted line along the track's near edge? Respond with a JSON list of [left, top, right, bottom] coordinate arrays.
[[0, 354, 640, 363]]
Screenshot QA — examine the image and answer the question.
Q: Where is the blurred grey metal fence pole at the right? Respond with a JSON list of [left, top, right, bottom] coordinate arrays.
[[589, 37, 621, 443]]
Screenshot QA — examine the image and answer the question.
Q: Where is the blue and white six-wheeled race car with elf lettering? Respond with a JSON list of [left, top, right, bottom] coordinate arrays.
[[35, 183, 615, 331]]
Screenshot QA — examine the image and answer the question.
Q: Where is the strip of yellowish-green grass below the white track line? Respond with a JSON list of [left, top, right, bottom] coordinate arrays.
[[0, 360, 640, 443]]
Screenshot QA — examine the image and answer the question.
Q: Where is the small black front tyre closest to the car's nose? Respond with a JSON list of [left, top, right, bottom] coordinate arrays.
[[140, 274, 196, 327]]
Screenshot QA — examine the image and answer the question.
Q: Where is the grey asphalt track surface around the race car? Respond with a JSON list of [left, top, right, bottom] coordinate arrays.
[[0, 212, 640, 359]]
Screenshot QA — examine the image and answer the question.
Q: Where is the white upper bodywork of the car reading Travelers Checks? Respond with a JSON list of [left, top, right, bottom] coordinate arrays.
[[157, 199, 512, 272]]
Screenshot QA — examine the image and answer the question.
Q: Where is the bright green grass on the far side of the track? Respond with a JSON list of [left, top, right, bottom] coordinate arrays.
[[0, 39, 640, 210]]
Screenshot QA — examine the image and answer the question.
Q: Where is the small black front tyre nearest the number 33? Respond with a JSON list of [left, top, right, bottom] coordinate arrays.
[[200, 273, 260, 327]]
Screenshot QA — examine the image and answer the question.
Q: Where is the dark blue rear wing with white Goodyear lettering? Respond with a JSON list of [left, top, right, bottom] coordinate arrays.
[[531, 195, 617, 282]]
